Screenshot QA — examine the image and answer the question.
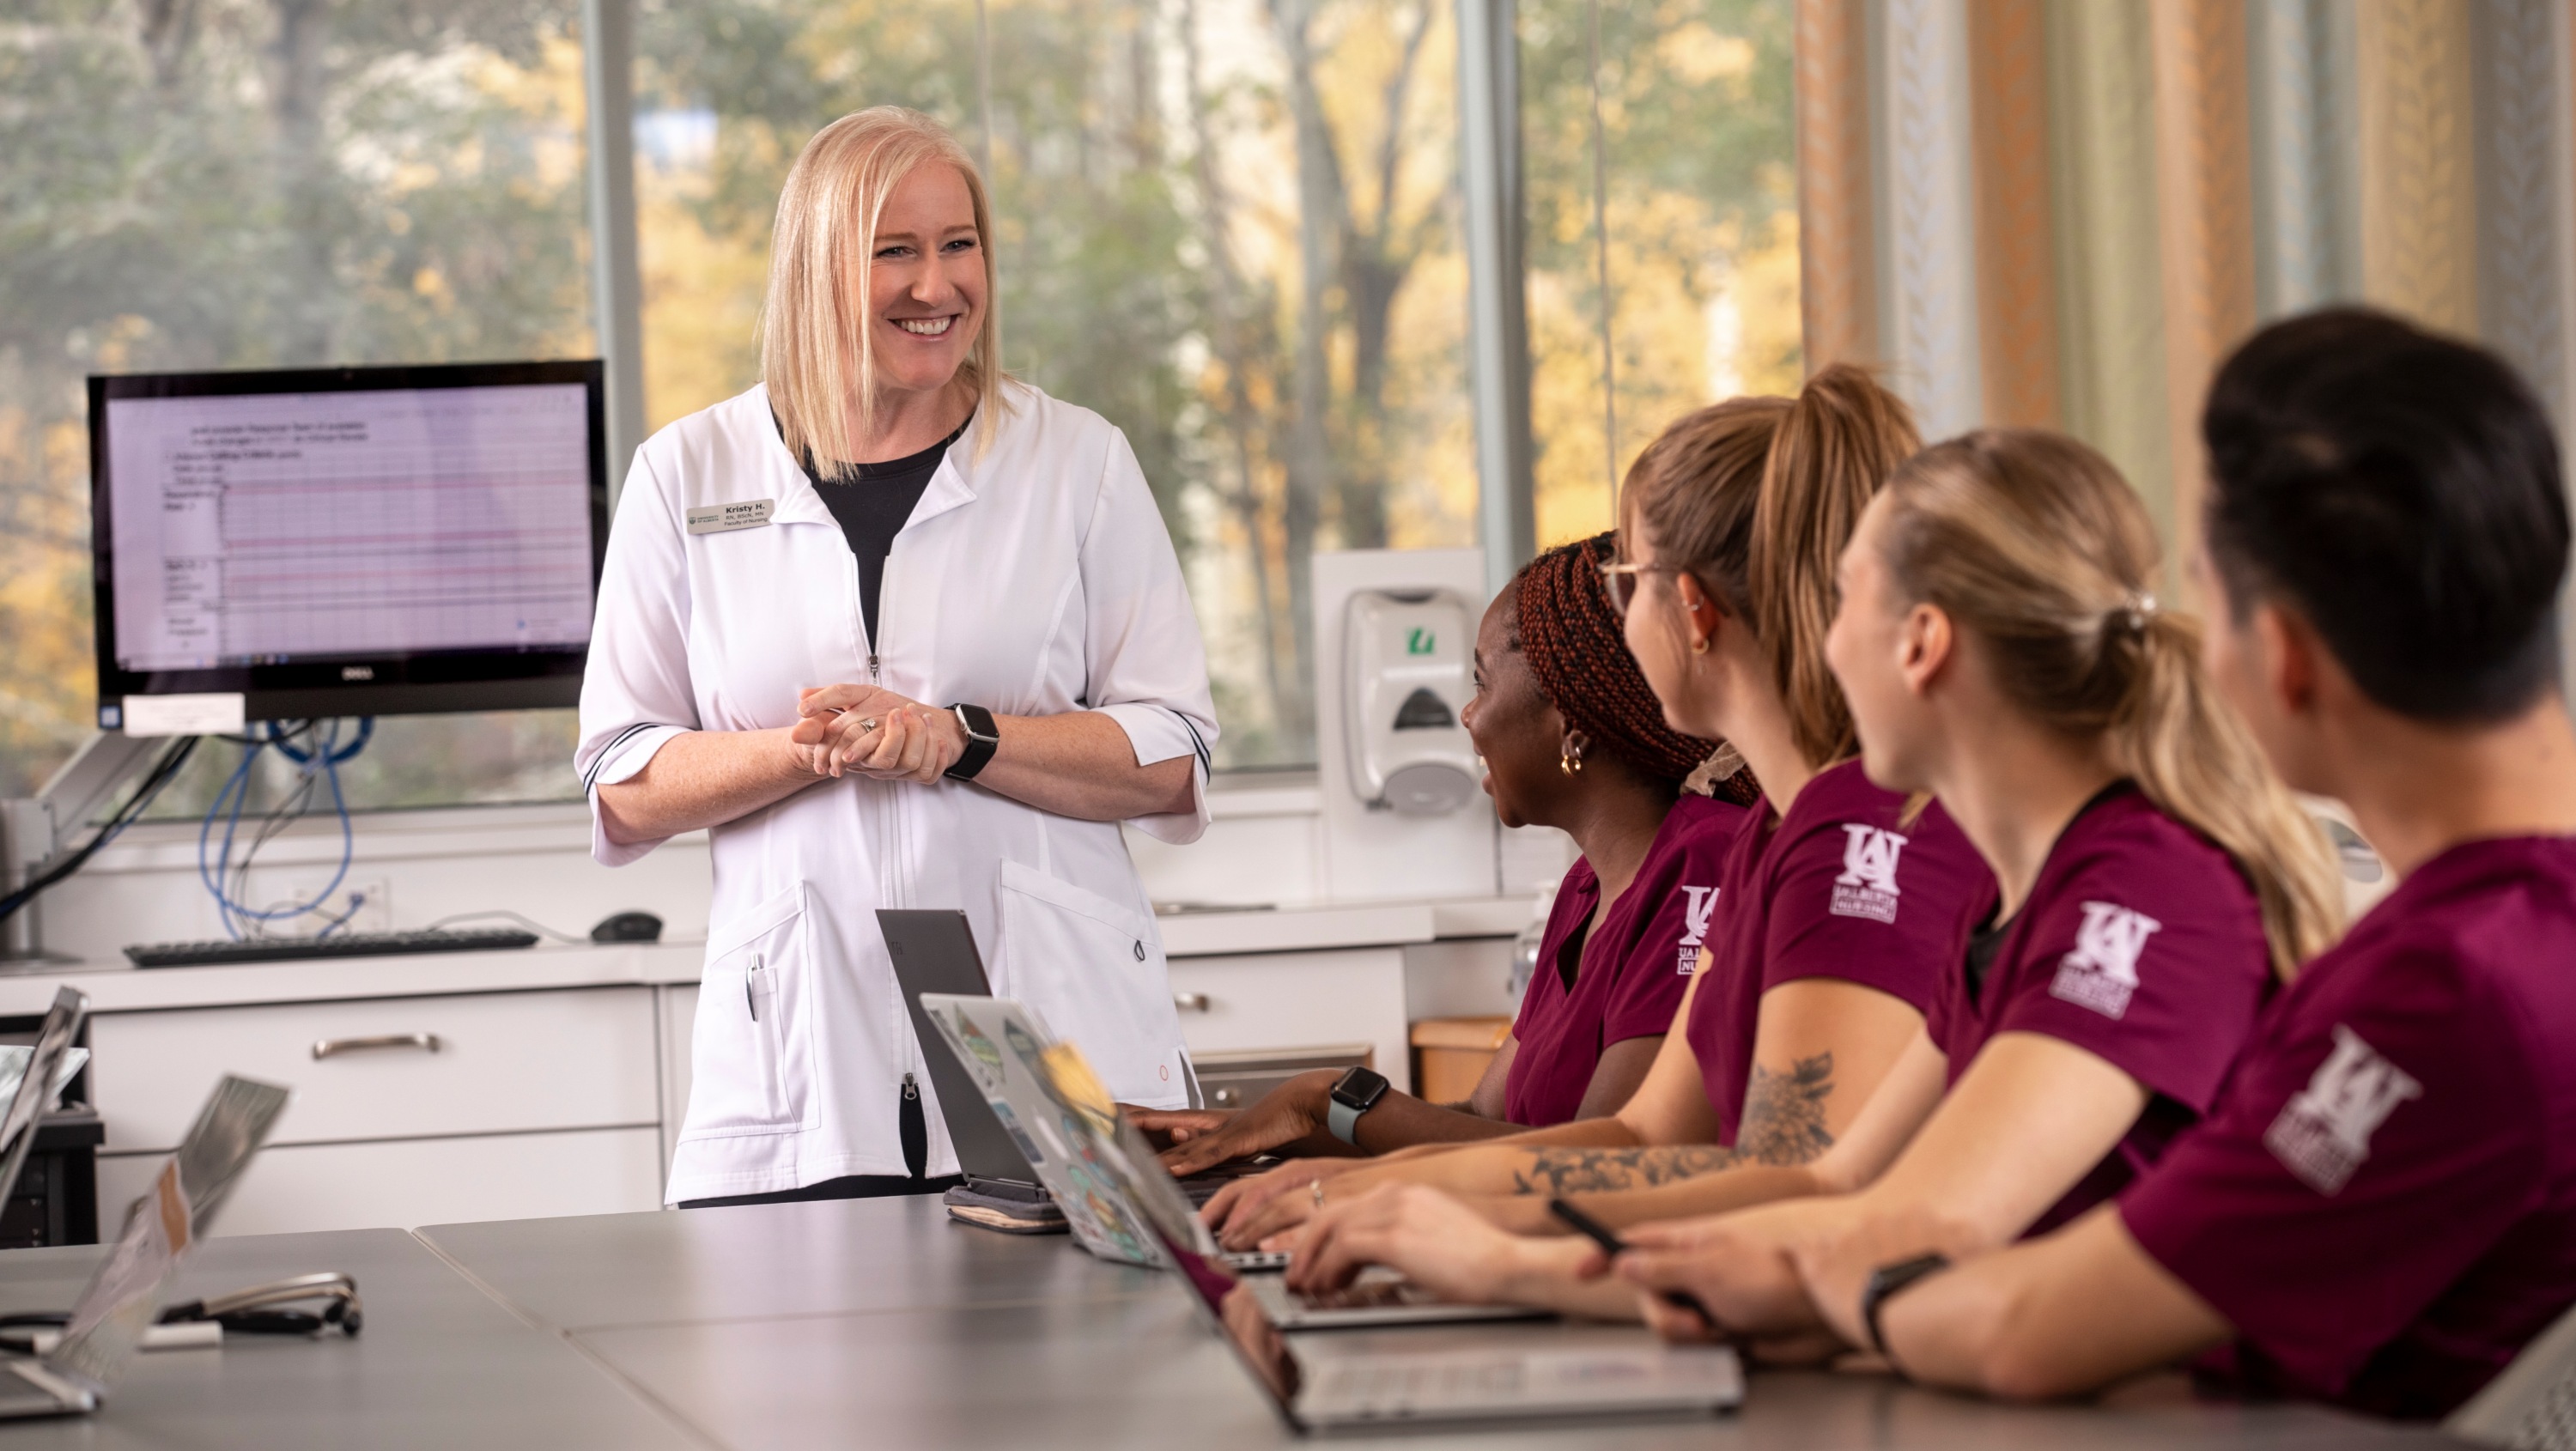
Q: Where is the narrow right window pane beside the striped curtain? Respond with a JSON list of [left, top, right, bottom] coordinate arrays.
[[1520, 0, 1803, 543]]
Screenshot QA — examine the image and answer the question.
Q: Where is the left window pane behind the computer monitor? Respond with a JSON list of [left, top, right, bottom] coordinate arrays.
[[0, 0, 592, 807]]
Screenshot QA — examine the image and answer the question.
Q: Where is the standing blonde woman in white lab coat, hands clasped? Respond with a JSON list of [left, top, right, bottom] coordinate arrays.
[[574, 106, 1216, 1204]]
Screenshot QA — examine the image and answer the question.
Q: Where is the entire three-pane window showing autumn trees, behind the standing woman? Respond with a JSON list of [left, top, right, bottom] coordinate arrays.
[[0, 0, 1798, 810]]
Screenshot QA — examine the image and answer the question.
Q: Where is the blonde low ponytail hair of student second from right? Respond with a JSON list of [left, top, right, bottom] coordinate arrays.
[[1883, 428, 2344, 977]]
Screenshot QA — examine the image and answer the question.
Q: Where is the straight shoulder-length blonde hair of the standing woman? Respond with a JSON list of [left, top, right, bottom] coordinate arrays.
[[760, 106, 1007, 466]]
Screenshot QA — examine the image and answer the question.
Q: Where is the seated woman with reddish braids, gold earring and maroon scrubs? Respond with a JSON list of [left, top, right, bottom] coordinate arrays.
[[1128, 533, 1757, 1173]]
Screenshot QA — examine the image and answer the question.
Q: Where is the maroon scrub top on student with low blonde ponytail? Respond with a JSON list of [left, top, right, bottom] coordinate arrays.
[[1924, 781, 2275, 1235]]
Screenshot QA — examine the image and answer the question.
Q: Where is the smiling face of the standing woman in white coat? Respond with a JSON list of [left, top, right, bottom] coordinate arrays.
[[868, 160, 989, 392]]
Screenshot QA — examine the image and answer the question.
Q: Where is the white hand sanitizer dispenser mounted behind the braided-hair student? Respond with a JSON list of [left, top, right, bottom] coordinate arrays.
[[1342, 590, 1479, 817]]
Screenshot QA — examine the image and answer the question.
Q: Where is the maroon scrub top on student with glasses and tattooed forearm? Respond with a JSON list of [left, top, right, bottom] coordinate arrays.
[[1687, 761, 1994, 1144]]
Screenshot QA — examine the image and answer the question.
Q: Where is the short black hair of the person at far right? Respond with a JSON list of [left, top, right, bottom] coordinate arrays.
[[2200, 307, 2568, 721]]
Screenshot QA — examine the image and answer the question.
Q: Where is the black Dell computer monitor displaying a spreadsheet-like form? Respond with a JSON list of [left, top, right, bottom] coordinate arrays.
[[90, 361, 608, 732]]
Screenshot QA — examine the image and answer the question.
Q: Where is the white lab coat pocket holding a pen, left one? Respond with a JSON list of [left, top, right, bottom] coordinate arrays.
[[680, 884, 814, 1139]]
